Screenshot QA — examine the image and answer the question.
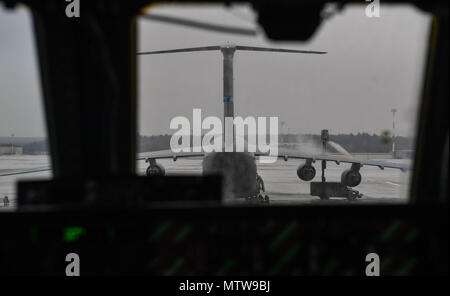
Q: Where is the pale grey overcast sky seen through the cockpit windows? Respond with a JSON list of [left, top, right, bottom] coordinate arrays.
[[0, 5, 430, 136]]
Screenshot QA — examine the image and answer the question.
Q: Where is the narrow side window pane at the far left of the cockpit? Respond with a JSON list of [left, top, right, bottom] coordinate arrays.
[[0, 5, 51, 211]]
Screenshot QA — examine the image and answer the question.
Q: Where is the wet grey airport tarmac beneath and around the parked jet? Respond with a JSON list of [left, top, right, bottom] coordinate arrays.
[[0, 155, 410, 210]]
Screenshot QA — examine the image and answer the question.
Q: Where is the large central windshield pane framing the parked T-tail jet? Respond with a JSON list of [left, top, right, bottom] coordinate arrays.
[[137, 5, 430, 204]]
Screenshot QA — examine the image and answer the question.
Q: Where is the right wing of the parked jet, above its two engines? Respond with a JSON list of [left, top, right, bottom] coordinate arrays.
[[255, 149, 410, 172]]
